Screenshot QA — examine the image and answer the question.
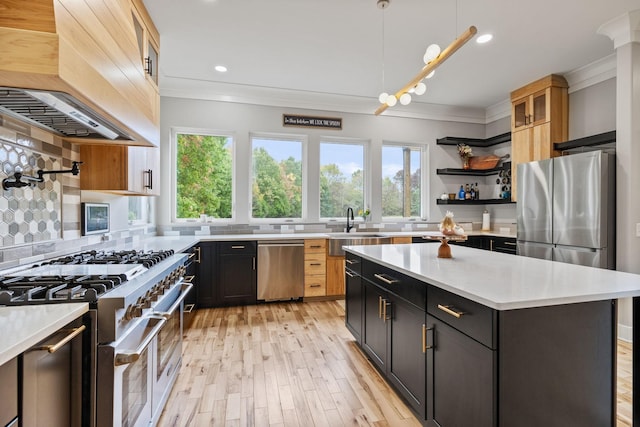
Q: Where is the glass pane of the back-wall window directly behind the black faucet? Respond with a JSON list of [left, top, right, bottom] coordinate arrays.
[[320, 141, 367, 218]]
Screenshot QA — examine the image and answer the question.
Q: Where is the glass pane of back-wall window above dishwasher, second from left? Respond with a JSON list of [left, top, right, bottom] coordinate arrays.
[[251, 135, 303, 219]]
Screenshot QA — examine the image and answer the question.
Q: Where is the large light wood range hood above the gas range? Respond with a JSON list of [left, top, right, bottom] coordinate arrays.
[[0, 0, 160, 146]]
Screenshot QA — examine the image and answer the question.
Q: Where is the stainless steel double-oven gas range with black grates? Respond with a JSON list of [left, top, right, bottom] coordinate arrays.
[[0, 251, 192, 427]]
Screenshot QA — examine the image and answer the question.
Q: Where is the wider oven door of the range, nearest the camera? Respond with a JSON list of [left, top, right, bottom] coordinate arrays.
[[97, 316, 167, 427]]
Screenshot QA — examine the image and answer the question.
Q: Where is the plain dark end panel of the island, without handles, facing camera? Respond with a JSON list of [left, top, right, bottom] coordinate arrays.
[[498, 300, 617, 427]]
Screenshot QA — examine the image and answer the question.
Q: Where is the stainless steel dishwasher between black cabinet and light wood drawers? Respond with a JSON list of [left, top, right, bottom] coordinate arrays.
[[258, 240, 304, 301]]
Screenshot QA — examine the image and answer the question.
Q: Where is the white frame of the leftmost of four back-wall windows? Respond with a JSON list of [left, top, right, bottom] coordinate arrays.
[[170, 127, 237, 224]]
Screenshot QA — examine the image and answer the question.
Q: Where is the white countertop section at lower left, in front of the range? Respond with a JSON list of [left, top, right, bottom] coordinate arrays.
[[0, 303, 89, 365]]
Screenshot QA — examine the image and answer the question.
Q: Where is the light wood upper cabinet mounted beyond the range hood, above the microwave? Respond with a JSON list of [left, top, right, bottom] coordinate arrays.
[[80, 145, 160, 196]]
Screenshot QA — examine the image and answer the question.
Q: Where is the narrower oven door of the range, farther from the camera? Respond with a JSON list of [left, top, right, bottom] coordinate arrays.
[[152, 283, 193, 422]]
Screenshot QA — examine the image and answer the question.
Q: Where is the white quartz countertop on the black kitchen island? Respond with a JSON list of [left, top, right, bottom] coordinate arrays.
[[345, 244, 640, 310]]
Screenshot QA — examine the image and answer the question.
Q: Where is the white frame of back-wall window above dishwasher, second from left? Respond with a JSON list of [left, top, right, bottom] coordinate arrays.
[[247, 132, 309, 224]]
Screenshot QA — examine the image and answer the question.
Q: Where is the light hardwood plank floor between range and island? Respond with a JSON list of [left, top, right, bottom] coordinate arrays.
[[158, 301, 631, 427]]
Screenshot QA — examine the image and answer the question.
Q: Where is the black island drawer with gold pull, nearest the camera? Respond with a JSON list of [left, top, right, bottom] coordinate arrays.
[[427, 286, 497, 349]]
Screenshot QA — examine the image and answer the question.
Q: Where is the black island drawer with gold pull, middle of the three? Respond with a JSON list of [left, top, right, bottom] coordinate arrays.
[[362, 260, 427, 310]]
